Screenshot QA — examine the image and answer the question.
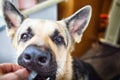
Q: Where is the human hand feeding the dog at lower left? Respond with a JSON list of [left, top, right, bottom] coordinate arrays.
[[0, 63, 29, 80]]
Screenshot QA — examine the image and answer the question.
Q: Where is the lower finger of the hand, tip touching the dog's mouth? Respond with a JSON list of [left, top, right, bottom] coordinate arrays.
[[0, 69, 29, 80]]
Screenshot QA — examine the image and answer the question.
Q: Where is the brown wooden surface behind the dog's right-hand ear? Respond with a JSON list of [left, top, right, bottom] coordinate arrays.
[[58, 0, 111, 57]]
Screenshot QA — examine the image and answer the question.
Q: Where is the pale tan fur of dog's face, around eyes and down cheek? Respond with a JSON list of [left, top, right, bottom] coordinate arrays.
[[10, 19, 73, 80]]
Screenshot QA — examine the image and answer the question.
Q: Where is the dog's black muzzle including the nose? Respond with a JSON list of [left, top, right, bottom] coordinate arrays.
[[18, 45, 57, 80]]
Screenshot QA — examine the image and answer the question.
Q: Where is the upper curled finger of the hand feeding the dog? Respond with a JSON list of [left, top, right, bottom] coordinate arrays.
[[0, 63, 23, 74]]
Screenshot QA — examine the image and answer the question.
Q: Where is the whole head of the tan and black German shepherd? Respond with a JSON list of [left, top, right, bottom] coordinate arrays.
[[3, 0, 91, 78]]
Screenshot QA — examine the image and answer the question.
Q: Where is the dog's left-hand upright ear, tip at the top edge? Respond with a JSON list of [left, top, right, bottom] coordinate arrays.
[[3, 0, 24, 37]]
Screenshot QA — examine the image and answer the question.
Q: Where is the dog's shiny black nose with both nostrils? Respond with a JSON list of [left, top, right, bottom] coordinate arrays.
[[22, 46, 50, 66]]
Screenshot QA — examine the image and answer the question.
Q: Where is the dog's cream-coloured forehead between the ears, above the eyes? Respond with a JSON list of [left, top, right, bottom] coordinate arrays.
[[18, 19, 61, 34]]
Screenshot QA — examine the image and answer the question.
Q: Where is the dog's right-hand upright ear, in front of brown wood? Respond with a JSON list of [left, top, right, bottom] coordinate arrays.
[[64, 5, 92, 43]]
